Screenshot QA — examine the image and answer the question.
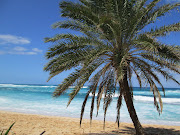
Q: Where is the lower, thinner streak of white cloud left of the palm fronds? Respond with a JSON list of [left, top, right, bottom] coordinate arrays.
[[0, 46, 42, 55]]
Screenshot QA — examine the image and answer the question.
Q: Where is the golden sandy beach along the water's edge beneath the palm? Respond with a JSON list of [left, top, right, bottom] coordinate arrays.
[[0, 111, 180, 135]]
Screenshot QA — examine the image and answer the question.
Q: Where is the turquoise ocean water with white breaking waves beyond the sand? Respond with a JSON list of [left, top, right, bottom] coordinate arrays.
[[0, 84, 180, 126]]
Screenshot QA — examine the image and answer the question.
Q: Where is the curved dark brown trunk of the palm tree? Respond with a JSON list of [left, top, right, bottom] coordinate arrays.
[[120, 75, 144, 135]]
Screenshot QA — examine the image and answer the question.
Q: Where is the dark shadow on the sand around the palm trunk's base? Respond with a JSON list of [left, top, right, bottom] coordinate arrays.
[[85, 127, 180, 135]]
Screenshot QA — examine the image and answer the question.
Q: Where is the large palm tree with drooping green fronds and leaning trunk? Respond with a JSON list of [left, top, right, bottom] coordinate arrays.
[[44, 0, 180, 135]]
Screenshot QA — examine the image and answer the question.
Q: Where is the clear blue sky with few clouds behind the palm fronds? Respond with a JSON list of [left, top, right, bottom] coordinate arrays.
[[0, 0, 180, 87]]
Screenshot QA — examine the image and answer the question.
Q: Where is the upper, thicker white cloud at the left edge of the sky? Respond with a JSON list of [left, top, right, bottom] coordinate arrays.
[[0, 34, 31, 45]]
